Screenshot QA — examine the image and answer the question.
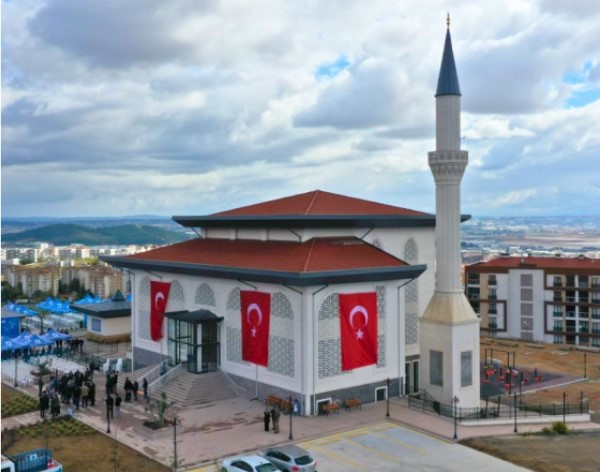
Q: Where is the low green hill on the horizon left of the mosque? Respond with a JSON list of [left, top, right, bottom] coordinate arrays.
[[2, 224, 189, 246]]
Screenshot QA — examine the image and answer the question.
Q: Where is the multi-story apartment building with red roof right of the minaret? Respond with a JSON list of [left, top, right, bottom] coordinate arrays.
[[465, 256, 600, 347]]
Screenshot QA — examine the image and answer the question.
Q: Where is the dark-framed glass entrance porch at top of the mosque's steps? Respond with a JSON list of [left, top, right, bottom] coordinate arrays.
[[164, 310, 223, 374]]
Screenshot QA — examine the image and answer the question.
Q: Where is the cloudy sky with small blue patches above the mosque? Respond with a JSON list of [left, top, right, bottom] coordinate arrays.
[[2, 0, 600, 217]]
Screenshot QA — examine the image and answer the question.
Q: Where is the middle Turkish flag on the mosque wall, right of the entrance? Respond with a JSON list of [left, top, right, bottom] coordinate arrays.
[[240, 290, 271, 367]]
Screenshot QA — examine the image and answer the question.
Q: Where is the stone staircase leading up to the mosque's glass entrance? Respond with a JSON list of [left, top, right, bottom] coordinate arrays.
[[150, 371, 237, 407]]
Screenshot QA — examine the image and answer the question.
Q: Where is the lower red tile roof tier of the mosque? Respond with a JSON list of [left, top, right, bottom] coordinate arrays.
[[126, 237, 408, 273]]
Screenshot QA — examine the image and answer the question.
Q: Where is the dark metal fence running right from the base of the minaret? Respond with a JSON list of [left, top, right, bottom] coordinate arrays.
[[408, 392, 589, 421]]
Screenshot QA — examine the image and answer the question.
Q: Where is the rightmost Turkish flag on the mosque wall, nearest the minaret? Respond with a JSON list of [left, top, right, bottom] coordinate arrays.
[[339, 292, 377, 370]]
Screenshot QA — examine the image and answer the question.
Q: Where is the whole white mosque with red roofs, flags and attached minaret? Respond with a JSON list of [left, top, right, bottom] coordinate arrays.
[[102, 20, 479, 415]]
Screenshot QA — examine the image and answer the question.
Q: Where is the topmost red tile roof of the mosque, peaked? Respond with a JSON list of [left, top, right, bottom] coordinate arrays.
[[214, 190, 430, 216]]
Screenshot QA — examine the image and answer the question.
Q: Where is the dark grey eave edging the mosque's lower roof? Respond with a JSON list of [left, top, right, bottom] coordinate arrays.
[[100, 256, 427, 287]]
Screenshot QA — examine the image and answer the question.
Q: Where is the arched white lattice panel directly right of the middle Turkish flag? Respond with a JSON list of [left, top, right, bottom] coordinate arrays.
[[267, 292, 296, 378]]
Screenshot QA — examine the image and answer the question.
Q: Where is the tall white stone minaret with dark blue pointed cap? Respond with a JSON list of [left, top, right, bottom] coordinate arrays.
[[419, 16, 479, 408]]
